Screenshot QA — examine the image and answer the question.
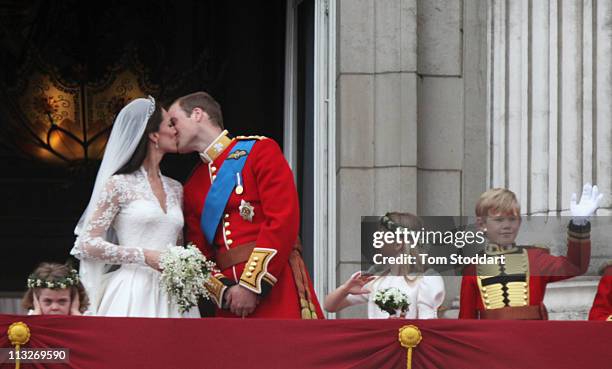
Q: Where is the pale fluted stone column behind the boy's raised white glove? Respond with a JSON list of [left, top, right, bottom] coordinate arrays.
[[488, 0, 612, 214]]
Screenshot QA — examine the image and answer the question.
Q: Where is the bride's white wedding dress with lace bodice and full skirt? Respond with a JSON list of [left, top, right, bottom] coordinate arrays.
[[71, 167, 200, 318]]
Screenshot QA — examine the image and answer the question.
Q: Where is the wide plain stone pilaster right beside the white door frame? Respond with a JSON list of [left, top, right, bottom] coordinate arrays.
[[336, 0, 417, 316]]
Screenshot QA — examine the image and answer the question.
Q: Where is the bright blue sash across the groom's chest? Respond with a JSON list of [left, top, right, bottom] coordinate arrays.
[[200, 140, 256, 245]]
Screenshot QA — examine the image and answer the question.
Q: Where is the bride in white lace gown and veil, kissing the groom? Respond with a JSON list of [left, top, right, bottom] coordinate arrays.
[[70, 96, 200, 318]]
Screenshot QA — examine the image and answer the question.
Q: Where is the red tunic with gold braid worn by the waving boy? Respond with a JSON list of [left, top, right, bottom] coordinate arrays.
[[459, 223, 591, 319]]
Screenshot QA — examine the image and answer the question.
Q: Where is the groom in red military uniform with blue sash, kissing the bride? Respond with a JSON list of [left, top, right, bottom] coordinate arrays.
[[168, 92, 323, 319]]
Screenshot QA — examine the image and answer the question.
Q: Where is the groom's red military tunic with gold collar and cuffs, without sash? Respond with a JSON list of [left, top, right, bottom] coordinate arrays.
[[184, 131, 323, 319]]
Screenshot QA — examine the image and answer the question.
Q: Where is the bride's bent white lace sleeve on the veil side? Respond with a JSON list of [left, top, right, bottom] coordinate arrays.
[[72, 176, 146, 265]]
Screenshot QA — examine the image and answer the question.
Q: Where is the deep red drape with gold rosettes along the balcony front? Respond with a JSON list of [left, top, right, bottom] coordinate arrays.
[[0, 315, 612, 369]]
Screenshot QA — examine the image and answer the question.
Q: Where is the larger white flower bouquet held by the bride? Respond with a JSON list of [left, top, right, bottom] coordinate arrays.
[[159, 243, 215, 313]]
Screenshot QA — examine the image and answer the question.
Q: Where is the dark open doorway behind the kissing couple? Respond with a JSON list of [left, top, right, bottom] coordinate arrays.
[[0, 0, 292, 302]]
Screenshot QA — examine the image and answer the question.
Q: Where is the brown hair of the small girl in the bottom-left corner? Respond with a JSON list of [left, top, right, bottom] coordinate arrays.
[[21, 263, 89, 313]]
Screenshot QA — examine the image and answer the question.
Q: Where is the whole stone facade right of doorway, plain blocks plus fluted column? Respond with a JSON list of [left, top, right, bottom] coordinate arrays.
[[336, 0, 612, 318]]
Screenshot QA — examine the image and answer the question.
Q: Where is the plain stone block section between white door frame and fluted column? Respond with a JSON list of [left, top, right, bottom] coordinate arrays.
[[337, 0, 487, 316]]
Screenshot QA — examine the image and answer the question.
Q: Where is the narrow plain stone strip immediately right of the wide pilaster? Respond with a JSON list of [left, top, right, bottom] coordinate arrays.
[[417, 0, 464, 215]]
